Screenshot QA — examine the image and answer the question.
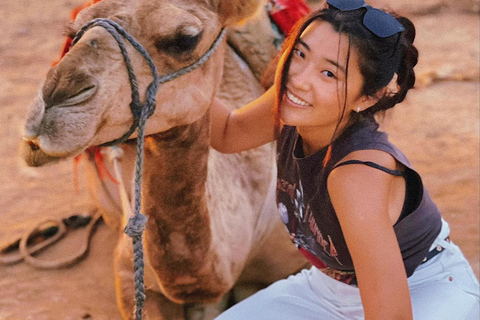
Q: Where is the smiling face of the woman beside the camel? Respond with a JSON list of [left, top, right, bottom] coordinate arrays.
[[281, 20, 373, 131]]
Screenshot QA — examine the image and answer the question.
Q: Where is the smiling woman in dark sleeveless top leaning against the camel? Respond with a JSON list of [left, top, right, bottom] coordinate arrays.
[[211, 0, 479, 320]]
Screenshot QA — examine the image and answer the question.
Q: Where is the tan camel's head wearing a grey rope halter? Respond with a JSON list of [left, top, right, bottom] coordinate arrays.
[[24, 0, 262, 166]]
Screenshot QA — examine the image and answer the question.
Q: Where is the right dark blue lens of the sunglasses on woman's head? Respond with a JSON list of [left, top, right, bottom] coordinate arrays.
[[363, 8, 405, 38]]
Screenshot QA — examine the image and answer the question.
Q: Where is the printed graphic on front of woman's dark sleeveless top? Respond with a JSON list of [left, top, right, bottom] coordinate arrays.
[[277, 178, 343, 265]]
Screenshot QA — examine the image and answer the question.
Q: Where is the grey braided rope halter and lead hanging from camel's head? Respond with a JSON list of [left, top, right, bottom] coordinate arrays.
[[72, 18, 225, 320]]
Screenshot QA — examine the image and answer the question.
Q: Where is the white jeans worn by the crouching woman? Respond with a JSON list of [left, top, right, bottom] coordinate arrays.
[[216, 222, 480, 320]]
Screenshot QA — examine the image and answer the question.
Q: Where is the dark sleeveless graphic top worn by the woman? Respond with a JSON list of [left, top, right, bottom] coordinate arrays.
[[277, 120, 442, 276]]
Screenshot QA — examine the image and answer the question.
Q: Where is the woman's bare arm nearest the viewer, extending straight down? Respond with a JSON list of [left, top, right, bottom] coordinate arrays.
[[328, 151, 412, 320]]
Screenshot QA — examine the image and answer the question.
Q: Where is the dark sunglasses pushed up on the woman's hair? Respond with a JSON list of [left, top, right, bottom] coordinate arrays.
[[327, 0, 405, 38]]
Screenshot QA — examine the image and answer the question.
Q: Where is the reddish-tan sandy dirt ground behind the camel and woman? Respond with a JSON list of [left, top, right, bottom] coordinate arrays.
[[0, 0, 479, 320]]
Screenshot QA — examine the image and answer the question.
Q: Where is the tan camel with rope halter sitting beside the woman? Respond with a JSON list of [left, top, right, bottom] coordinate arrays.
[[23, 0, 308, 320]]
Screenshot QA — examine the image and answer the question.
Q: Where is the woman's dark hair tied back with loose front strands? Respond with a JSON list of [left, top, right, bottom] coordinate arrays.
[[276, 8, 418, 132]]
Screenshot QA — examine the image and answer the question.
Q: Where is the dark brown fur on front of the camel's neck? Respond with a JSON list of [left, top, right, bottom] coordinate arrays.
[[143, 112, 211, 276]]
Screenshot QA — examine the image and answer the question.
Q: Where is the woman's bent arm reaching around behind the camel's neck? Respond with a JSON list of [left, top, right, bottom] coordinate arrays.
[[210, 87, 275, 153]]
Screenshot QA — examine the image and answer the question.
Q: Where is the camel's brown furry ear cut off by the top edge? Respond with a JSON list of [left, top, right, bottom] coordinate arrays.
[[217, 0, 264, 26]]
